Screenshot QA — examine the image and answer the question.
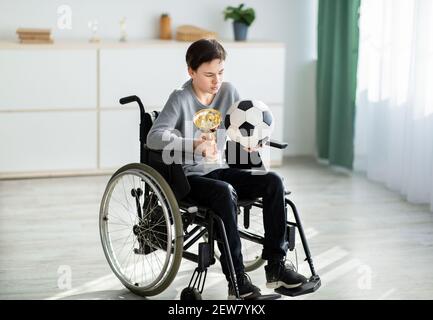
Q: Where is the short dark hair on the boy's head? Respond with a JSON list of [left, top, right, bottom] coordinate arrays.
[[186, 39, 226, 70]]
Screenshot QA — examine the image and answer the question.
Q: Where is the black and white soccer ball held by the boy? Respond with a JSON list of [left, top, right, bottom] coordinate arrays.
[[224, 100, 274, 148]]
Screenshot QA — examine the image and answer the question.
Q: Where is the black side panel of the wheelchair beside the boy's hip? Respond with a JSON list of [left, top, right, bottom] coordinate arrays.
[[142, 146, 191, 200]]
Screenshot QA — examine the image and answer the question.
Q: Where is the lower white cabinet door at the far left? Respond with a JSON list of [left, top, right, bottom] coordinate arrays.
[[0, 111, 97, 174]]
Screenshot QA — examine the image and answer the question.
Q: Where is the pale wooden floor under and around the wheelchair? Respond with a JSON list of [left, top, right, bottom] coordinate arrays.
[[0, 158, 433, 300]]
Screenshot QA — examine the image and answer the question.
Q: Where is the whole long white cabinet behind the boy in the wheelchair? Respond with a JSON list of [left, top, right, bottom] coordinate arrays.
[[0, 41, 285, 178]]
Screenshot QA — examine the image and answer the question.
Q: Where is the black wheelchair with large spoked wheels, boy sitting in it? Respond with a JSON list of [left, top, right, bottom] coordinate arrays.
[[99, 96, 321, 300]]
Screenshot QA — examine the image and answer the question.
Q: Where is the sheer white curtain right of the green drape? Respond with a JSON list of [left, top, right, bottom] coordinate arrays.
[[354, 0, 433, 211]]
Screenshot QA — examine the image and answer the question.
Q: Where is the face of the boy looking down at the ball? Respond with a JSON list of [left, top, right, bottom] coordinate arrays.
[[188, 59, 224, 94]]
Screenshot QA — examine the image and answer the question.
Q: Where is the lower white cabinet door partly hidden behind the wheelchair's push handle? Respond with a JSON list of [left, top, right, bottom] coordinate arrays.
[[100, 108, 140, 169]]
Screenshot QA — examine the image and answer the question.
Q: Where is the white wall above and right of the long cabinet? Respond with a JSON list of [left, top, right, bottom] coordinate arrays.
[[0, 0, 317, 155]]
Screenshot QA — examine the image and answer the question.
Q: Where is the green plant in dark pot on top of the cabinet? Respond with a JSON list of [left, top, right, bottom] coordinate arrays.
[[223, 3, 256, 41]]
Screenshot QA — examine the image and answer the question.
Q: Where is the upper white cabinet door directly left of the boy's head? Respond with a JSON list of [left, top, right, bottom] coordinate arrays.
[[100, 48, 189, 109]]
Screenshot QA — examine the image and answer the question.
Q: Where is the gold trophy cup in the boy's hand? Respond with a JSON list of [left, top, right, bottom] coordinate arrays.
[[193, 109, 222, 163]]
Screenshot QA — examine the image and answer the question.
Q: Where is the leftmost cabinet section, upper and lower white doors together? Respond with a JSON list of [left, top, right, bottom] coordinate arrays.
[[0, 45, 98, 177]]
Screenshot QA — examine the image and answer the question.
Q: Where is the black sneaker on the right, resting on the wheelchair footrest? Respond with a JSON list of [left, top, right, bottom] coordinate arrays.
[[265, 261, 308, 289]]
